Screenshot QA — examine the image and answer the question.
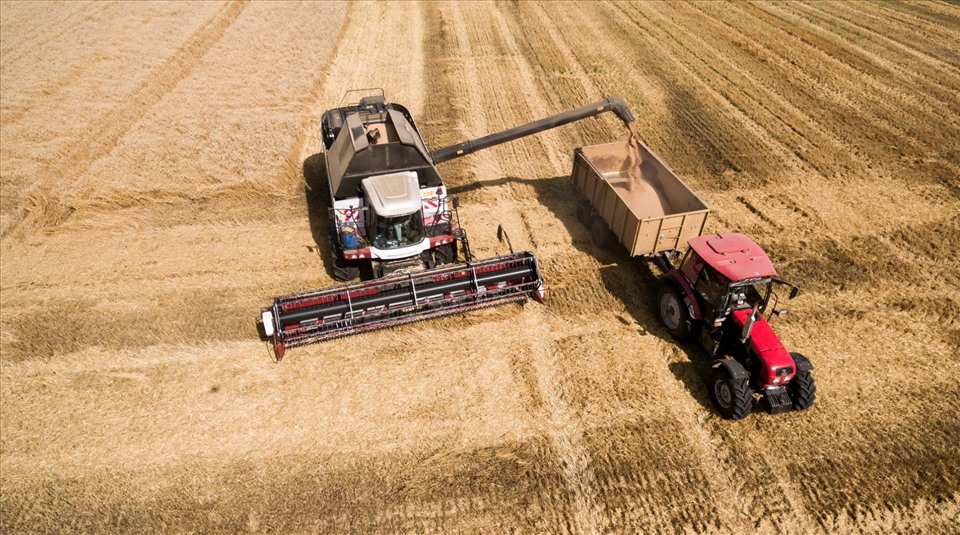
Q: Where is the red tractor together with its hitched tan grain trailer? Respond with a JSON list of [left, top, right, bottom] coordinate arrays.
[[572, 137, 816, 420]]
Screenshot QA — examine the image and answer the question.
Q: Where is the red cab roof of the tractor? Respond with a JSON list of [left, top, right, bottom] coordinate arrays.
[[687, 236, 777, 282]]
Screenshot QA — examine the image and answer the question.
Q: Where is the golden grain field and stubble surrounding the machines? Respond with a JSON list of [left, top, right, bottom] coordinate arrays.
[[0, 2, 960, 534]]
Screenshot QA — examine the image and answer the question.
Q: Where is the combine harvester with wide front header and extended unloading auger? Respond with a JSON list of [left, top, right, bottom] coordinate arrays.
[[261, 90, 634, 360]]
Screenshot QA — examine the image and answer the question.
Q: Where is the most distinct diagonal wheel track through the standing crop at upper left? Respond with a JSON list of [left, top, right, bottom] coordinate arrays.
[[7, 0, 247, 236]]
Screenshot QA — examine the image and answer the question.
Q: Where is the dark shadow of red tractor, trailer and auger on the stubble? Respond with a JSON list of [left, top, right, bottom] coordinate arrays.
[[448, 175, 713, 412]]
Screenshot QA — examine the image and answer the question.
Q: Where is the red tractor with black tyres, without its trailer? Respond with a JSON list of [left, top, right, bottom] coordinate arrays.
[[653, 233, 817, 420]]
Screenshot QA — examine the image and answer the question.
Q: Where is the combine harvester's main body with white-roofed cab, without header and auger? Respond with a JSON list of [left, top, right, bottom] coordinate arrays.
[[320, 90, 470, 281]]
